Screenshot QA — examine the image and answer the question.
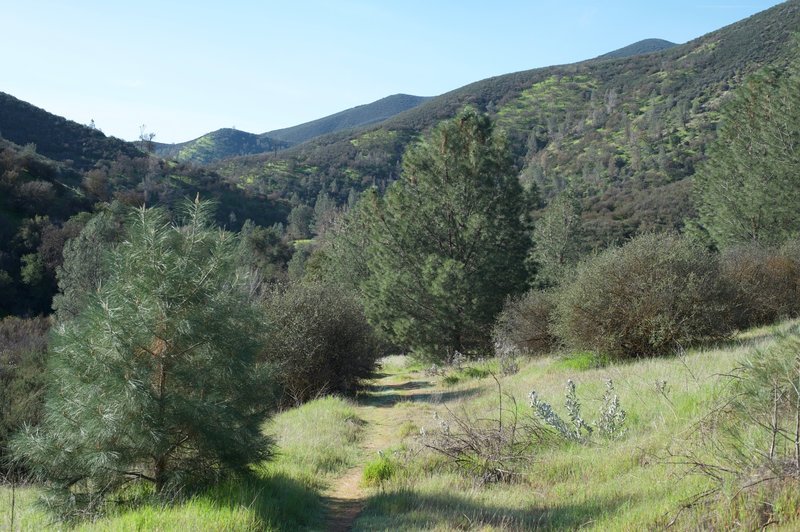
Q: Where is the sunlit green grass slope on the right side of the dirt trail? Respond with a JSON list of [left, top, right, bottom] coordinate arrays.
[[355, 325, 800, 530]]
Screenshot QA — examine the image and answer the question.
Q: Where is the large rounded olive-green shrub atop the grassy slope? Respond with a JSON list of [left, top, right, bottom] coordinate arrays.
[[554, 234, 731, 358]]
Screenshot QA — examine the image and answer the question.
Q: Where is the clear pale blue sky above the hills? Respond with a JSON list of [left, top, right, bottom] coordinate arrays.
[[0, 0, 780, 142]]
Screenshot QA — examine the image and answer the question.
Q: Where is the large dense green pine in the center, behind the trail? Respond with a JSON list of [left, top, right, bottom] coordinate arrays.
[[363, 110, 527, 360]]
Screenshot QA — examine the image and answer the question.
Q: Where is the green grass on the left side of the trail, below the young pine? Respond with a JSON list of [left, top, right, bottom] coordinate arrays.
[[0, 397, 362, 531]]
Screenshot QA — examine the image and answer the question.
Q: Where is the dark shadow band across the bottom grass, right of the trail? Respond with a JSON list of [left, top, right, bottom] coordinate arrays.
[[353, 489, 633, 530]]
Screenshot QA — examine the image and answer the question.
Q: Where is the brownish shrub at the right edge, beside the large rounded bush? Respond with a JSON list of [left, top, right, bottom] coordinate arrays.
[[721, 244, 800, 328]]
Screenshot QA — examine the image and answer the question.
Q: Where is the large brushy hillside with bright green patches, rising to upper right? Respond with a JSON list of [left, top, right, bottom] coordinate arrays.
[[217, 0, 800, 248]]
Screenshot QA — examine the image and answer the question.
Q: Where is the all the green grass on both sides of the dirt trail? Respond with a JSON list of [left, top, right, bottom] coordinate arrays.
[[0, 323, 800, 531]]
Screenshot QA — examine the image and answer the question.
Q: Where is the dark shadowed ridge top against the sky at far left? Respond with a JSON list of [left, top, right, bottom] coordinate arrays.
[[0, 92, 143, 170]]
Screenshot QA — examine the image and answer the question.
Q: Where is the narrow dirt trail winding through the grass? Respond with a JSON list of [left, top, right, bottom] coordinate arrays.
[[325, 368, 441, 532]]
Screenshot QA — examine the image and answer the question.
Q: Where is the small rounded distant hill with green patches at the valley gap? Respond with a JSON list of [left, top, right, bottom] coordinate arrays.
[[154, 128, 289, 164]]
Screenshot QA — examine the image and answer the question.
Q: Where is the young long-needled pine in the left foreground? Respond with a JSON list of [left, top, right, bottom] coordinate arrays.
[[13, 201, 269, 516]]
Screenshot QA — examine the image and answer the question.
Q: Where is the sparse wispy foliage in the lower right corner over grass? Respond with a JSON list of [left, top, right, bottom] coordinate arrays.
[[670, 325, 800, 527]]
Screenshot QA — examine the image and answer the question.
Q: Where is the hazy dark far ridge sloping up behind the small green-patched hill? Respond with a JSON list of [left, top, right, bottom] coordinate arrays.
[[264, 94, 430, 144]]
